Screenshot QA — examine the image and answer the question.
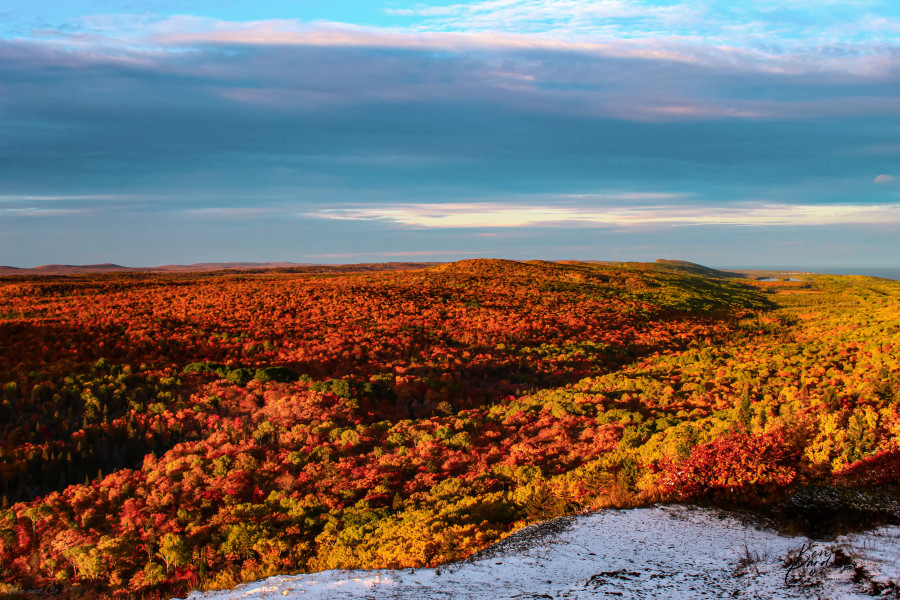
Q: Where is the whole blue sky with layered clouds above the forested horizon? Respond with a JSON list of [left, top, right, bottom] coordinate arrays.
[[0, 0, 900, 267]]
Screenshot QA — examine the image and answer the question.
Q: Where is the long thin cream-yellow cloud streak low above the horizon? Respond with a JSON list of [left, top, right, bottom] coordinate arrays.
[[309, 203, 900, 229]]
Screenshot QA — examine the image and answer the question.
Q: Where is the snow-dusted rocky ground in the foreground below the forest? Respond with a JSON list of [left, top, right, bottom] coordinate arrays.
[[183, 506, 900, 600]]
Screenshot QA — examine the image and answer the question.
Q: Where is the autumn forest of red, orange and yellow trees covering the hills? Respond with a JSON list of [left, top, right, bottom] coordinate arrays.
[[0, 260, 900, 598]]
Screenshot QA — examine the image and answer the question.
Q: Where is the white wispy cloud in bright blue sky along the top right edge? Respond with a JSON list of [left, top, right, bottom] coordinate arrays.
[[388, 0, 898, 47]]
